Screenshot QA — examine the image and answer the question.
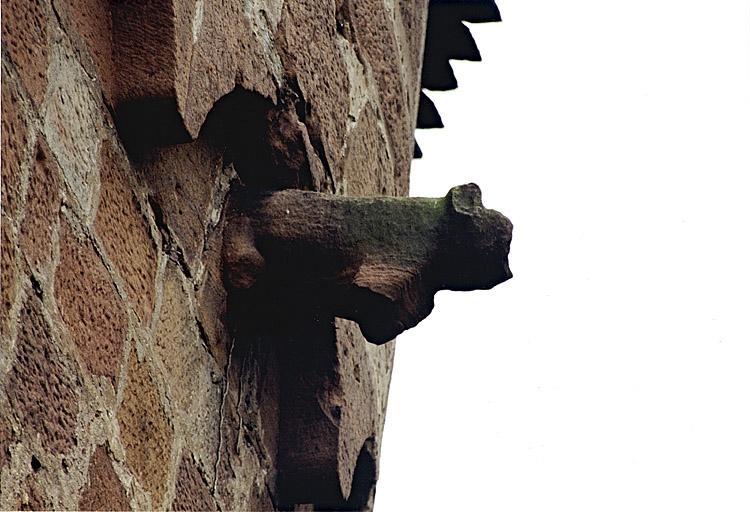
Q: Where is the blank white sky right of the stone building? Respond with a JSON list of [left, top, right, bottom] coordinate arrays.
[[376, 0, 750, 512]]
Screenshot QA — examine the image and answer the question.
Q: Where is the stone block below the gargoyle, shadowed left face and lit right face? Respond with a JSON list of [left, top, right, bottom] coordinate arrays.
[[272, 318, 389, 510]]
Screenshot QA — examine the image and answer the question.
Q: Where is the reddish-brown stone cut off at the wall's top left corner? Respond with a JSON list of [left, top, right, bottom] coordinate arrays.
[[2, 0, 51, 106]]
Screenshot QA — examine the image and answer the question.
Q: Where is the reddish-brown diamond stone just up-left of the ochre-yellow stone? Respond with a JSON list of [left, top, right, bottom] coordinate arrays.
[[55, 215, 127, 387]]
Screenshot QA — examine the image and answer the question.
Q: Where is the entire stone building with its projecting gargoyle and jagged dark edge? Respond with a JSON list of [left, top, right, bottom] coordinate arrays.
[[0, 0, 510, 511]]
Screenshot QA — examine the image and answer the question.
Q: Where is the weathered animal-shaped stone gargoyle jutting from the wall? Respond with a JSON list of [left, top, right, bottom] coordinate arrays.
[[224, 183, 513, 344]]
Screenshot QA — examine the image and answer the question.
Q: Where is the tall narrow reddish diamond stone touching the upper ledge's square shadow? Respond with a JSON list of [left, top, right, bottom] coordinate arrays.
[[94, 139, 157, 326]]
